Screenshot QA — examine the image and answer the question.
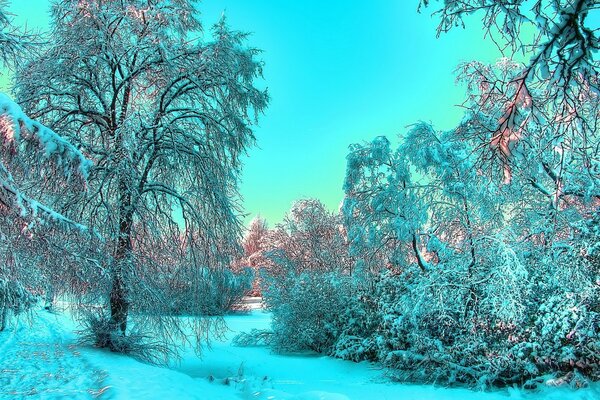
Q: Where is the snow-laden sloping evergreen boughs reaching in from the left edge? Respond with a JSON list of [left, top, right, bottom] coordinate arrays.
[[0, 94, 97, 318]]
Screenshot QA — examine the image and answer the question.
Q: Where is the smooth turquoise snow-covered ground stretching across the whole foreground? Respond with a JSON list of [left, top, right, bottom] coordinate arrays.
[[0, 310, 600, 400]]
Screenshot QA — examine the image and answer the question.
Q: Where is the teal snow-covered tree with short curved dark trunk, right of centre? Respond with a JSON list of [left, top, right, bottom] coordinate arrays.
[[342, 137, 428, 275]]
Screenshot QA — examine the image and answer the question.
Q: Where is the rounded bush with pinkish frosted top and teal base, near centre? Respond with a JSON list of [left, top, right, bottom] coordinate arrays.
[[261, 200, 358, 353]]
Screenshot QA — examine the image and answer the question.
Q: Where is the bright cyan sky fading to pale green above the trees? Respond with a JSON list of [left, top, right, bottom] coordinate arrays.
[[10, 0, 508, 225]]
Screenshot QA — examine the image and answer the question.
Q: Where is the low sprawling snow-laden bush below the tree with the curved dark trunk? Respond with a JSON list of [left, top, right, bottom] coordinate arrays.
[[377, 267, 532, 387]]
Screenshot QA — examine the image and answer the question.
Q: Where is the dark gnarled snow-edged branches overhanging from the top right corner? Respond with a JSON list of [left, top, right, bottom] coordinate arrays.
[[420, 0, 600, 102]]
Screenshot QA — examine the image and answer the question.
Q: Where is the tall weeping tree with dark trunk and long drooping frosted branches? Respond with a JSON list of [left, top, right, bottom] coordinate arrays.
[[16, 0, 268, 356]]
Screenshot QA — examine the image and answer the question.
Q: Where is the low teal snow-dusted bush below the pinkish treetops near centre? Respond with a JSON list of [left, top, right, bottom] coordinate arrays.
[[262, 271, 380, 361]]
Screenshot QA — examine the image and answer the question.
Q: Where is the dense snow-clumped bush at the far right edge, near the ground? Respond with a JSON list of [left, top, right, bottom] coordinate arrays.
[[510, 211, 600, 386]]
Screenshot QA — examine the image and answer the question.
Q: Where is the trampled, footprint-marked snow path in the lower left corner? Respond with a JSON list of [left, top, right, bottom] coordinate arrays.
[[0, 311, 107, 399]]
